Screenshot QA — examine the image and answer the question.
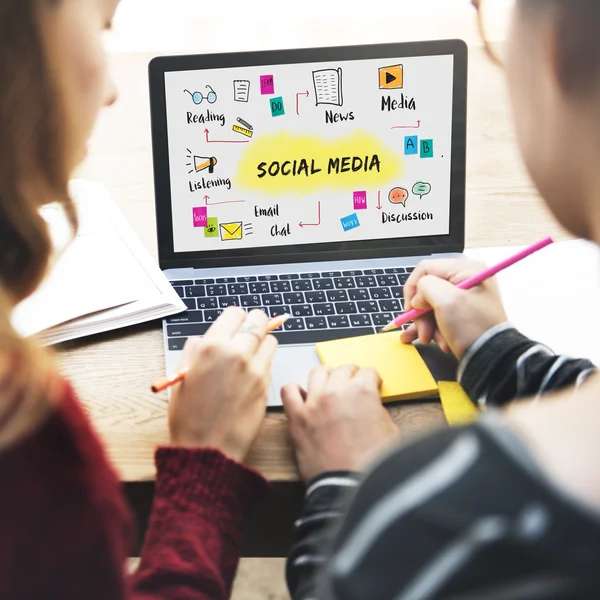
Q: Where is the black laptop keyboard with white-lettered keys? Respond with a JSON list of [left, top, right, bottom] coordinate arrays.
[[166, 267, 414, 350]]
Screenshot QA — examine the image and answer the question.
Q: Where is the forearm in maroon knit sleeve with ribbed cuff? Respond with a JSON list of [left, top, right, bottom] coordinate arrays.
[[132, 448, 267, 600]]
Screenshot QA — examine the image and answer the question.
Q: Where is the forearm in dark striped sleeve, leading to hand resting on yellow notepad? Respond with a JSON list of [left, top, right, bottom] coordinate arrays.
[[286, 471, 359, 600]]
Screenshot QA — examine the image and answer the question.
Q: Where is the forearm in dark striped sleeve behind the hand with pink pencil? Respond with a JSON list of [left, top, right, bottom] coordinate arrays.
[[458, 323, 595, 406]]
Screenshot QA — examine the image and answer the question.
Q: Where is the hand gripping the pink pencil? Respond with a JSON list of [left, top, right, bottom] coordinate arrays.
[[401, 259, 507, 359]]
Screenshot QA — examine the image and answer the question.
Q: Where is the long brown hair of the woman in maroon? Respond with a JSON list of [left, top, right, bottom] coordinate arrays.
[[0, 0, 77, 440]]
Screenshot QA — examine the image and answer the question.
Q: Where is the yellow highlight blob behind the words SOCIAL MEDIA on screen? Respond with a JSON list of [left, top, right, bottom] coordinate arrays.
[[235, 131, 404, 196]]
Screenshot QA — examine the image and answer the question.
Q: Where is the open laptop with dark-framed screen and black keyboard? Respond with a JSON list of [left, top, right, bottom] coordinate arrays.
[[149, 40, 467, 406]]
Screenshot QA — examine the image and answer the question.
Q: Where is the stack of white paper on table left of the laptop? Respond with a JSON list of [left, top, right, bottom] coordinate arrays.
[[12, 180, 185, 345]]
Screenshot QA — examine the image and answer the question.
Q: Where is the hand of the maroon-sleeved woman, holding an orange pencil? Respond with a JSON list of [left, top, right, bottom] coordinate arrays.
[[169, 307, 277, 462]]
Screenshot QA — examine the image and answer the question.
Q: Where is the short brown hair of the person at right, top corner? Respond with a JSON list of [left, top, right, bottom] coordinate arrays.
[[519, 0, 600, 93]]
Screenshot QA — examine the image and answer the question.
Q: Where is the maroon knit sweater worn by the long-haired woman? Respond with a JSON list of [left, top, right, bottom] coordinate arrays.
[[0, 384, 267, 600]]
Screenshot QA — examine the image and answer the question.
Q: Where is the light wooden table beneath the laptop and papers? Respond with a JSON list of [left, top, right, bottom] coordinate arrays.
[[58, 49, 567, 556]]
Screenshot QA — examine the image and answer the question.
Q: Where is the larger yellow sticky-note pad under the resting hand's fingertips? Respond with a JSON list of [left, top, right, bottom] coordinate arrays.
[[317, 333, 438, 402]]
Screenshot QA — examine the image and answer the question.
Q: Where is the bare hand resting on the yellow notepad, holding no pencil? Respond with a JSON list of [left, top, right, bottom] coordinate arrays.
[[281, 365, 398, 481]]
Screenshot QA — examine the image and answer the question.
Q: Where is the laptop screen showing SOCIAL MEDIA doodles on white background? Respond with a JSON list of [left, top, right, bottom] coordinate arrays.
[[151, 42, 464, 268]]
